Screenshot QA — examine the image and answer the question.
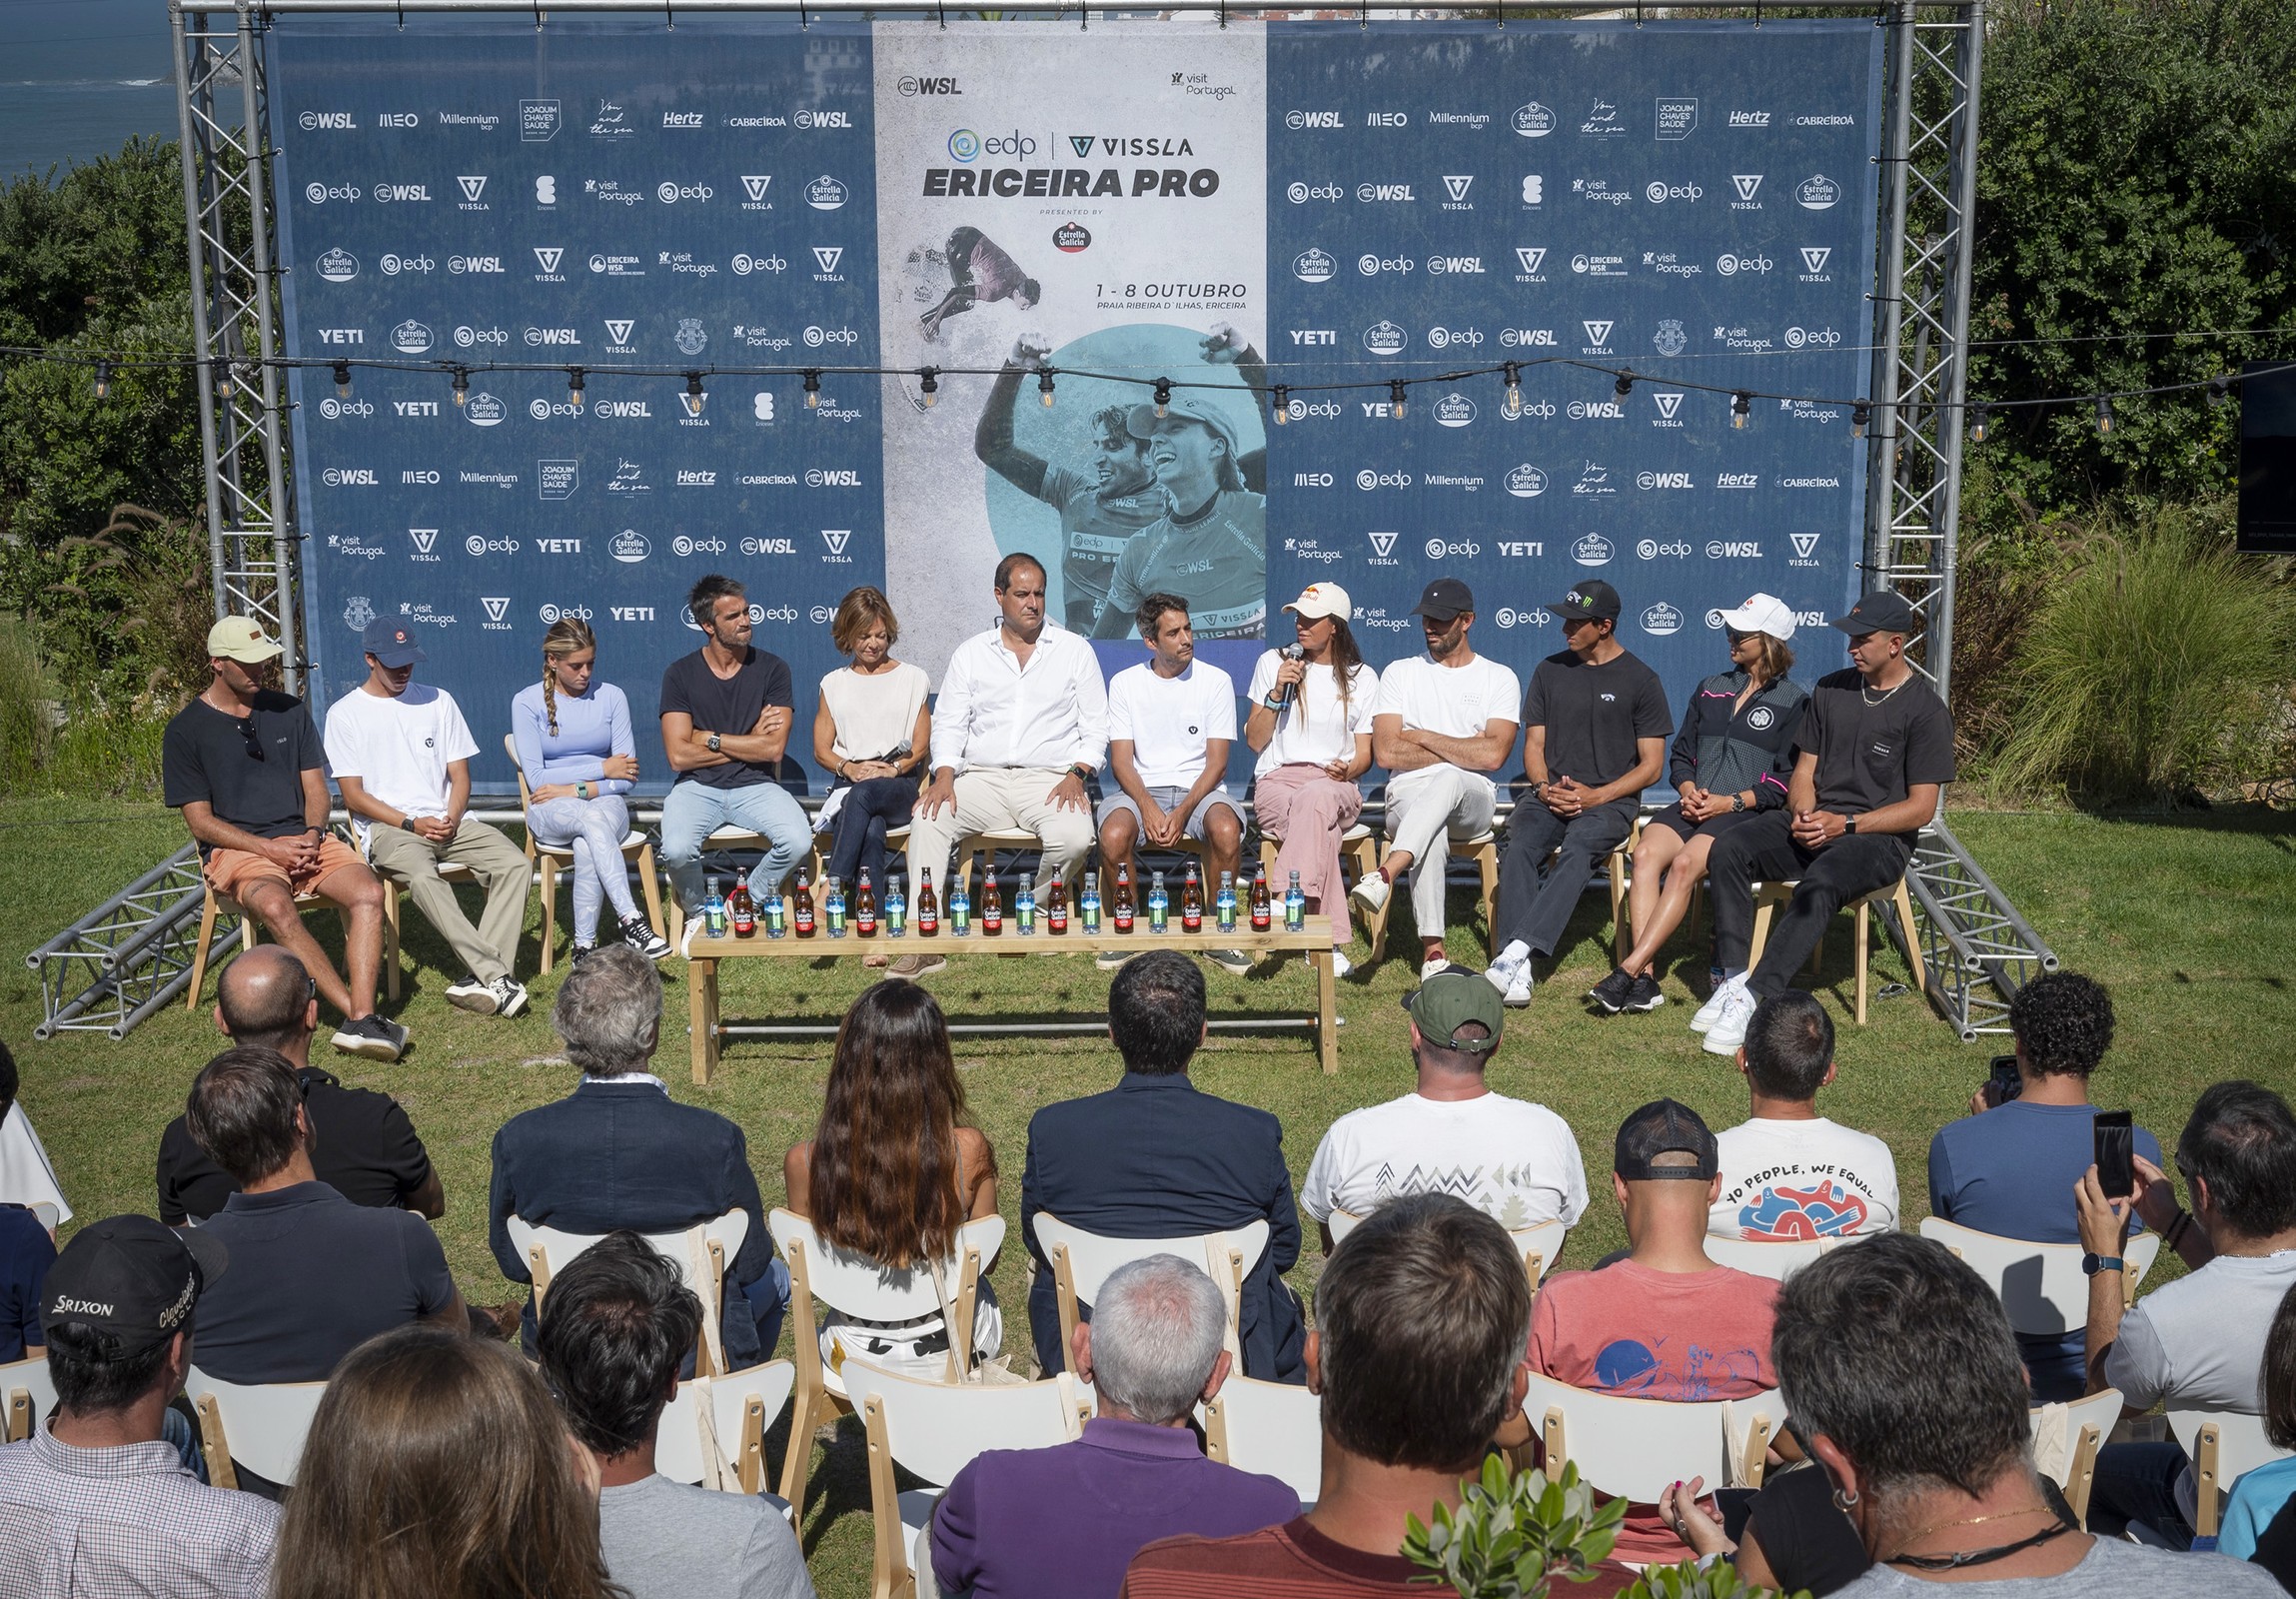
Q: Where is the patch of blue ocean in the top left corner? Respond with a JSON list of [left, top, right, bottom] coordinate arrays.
[[0, 0, 177, 179]]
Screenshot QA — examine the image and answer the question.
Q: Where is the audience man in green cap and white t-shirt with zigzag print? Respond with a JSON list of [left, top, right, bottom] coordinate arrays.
[[1300, 967, 1587, 1252]]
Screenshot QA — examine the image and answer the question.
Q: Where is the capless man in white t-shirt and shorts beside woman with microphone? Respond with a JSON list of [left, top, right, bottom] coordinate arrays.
[[1097, 593, 1251, 976]]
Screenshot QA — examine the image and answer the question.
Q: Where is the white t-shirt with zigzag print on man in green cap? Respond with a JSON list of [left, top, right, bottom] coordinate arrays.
[[1300, 1093, 1587, 1231]]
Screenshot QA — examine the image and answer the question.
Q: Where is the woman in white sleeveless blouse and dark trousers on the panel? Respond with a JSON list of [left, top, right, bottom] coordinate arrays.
[[812, 586, 932, 965]]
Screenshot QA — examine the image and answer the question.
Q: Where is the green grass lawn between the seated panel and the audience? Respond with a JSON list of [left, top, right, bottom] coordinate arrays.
[[0, 801, 2296, 1599]]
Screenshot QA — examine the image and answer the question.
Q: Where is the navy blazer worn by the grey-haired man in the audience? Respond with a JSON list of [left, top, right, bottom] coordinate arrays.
[[487, 1077, 773, 1369]]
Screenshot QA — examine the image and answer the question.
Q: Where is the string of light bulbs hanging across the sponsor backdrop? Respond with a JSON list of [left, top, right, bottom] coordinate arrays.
[[0, 345, 2296, 444]]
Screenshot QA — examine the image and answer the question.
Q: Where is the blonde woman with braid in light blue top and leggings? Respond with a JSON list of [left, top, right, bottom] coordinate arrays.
[[510, 616, 670, 960]]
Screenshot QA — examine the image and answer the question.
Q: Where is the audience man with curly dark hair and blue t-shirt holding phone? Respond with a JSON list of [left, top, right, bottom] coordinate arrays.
[[1928, 971, 2160, 1404]]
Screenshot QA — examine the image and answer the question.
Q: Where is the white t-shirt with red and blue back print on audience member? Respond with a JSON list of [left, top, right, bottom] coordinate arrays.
[[1706, 1116, 1896, 1243]]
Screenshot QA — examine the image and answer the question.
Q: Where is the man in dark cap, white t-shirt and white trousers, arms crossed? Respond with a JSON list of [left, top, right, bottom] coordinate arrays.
[[1355, 577, 1523, 981]]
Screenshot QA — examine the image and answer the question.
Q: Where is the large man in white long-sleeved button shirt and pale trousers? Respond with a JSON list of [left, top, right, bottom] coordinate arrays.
[[909, 554, 1109, 909]]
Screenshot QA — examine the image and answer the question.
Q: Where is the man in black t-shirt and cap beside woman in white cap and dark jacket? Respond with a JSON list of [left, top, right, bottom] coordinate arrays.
[[1486, 582, 1674, 1004]]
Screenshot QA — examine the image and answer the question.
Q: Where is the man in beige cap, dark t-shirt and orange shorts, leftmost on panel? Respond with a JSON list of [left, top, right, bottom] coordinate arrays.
[[161, 616, 407, 1061]]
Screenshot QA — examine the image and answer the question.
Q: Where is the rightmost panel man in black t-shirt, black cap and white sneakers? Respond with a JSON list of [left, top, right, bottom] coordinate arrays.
[[1690, 589, 1954, 1054]]
